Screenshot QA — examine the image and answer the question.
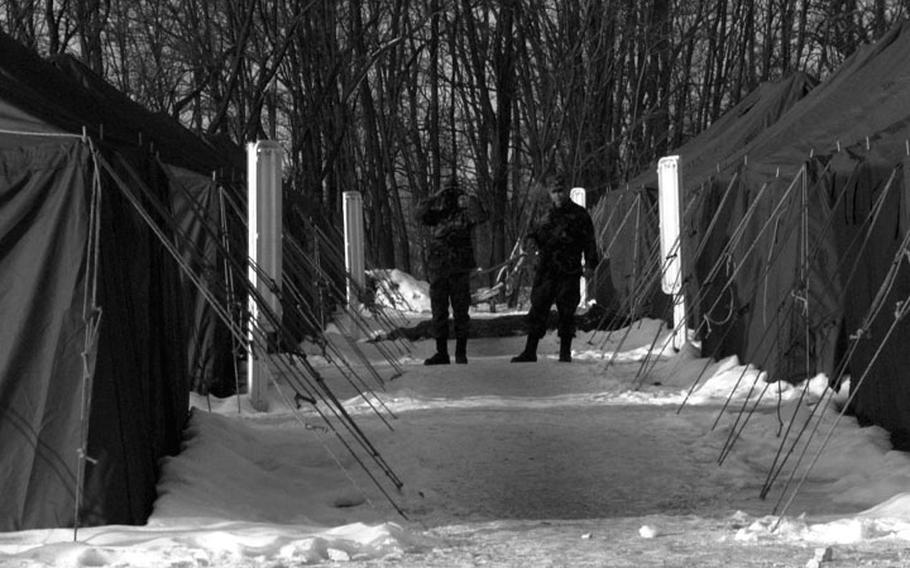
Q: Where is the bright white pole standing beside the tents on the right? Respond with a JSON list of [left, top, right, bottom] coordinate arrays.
[[657, 156, 688, 349]]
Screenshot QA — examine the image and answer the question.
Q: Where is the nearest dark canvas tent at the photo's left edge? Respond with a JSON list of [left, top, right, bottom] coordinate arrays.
[[0, 32, 240, 530]]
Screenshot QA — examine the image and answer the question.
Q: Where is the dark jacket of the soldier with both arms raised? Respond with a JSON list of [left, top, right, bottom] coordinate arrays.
[[417, 191, 484, 278]]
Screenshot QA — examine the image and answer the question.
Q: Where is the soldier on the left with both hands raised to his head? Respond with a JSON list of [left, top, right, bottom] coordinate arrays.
[[417, 177, 486, 365]]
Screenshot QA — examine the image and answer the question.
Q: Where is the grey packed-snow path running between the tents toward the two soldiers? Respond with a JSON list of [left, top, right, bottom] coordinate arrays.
[[302, 340, 856, 526]]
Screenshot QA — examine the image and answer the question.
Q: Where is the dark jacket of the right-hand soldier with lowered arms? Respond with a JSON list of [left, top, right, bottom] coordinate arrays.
[[528, 201, 600, 280]]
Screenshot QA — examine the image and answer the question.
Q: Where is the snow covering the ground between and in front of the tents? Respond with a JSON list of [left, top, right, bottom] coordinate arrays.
[[0, 273, 910, 567]]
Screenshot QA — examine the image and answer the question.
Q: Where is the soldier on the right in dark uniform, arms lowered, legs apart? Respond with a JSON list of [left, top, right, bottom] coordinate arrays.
[[512, 172, 599, 363]]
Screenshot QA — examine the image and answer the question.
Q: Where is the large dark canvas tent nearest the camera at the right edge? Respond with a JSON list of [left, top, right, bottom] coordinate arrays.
[[608, 23, 910, 439]]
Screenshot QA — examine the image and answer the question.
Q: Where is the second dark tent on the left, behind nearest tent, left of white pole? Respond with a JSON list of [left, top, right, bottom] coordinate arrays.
[[51, 55, 246, 395]]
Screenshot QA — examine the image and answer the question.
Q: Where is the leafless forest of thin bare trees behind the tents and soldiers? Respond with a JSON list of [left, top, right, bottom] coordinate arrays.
[[0, 0, 910, 273]]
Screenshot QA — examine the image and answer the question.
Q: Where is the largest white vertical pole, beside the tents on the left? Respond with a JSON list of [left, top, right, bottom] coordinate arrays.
[[247, 140, 284, 411]]
